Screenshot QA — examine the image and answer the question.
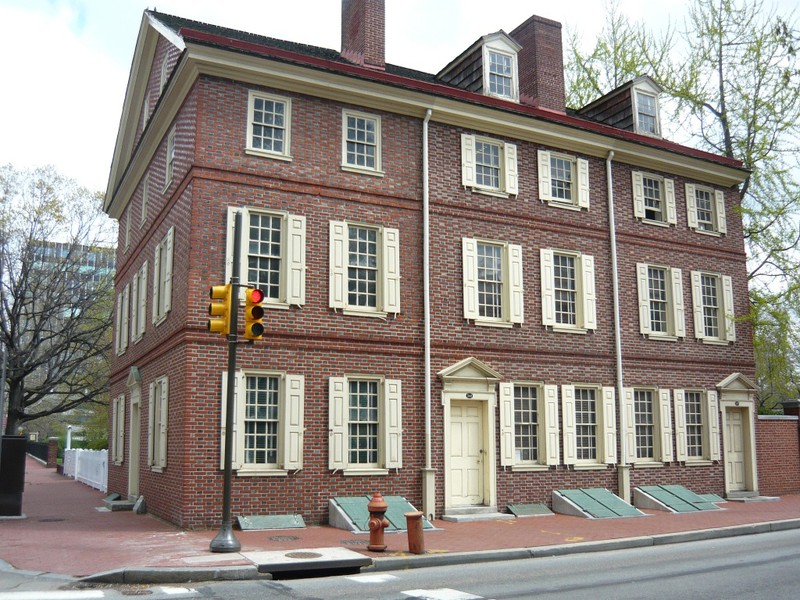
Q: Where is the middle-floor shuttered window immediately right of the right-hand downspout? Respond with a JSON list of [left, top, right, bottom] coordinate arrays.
[[636, 263, 686, 340]]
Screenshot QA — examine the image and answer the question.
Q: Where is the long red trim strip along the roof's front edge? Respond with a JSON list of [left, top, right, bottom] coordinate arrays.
[[178, 27, 744, 169]]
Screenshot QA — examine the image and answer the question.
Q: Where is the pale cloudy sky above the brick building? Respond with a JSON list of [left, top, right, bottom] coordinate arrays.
[[0, 0, 797, 191]]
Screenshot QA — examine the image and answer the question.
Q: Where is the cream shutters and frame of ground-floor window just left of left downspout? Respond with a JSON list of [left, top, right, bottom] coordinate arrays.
[[328, 374, 403, 476]]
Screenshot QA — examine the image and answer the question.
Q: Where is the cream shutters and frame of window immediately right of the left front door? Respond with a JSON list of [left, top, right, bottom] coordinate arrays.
[[500, 381, 560, 471]]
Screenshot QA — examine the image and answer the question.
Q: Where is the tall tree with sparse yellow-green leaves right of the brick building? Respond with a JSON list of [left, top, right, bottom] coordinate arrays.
[[567, 0, 800, 402]]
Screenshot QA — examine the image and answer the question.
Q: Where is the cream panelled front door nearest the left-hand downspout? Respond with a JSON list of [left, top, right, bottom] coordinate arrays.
[[448, 402, 485, 506]]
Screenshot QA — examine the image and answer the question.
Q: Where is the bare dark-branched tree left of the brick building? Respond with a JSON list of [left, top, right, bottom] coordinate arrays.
[[0, 165, 114, 434]]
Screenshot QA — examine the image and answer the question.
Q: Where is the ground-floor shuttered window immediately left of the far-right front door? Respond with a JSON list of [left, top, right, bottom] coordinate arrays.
[[674, 390, 720, 464]]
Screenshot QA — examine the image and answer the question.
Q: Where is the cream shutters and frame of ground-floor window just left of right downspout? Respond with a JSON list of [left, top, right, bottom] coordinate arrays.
[[561, 383, 617, 470]]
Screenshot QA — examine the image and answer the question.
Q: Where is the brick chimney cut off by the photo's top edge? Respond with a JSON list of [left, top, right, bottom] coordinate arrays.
[[341, 0, 386, 70]]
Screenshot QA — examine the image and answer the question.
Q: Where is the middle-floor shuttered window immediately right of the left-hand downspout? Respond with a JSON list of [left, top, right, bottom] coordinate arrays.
[[461, 238, 524, 327]]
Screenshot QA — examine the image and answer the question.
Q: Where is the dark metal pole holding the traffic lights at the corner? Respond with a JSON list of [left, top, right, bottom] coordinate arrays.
[[209, 212, 242, 552]]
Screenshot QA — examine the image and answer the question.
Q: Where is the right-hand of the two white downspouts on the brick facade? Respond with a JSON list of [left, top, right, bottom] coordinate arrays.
[[606, 150, 631, 502]]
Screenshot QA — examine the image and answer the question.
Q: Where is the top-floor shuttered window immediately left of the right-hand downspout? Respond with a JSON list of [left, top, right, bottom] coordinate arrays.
[[538, 150, 589, 210]]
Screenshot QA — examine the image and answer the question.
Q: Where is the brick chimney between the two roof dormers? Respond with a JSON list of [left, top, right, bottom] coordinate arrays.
[[511, 15, 566, 113]]
